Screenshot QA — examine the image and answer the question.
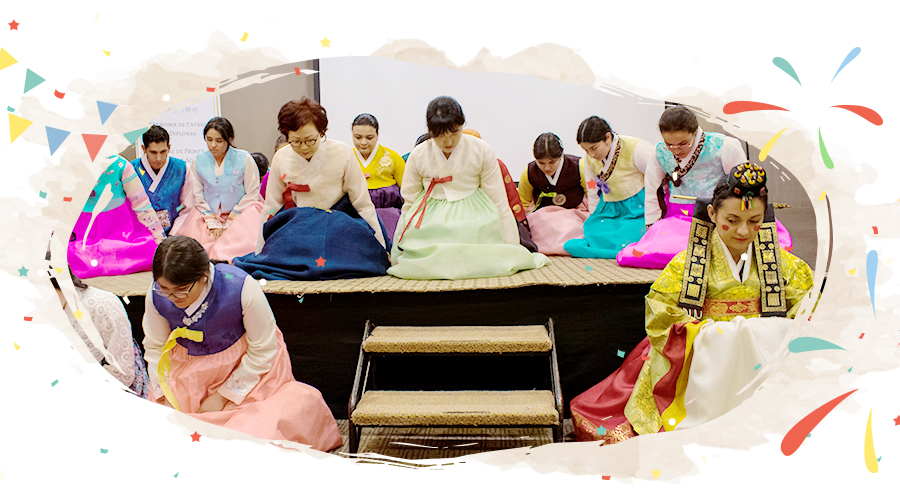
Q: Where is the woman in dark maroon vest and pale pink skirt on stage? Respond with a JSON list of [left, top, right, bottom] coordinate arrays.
[[519, 133, 590, 256]]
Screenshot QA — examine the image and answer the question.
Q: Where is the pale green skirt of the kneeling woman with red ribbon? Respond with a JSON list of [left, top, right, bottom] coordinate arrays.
[[388, 187, 550, 279]]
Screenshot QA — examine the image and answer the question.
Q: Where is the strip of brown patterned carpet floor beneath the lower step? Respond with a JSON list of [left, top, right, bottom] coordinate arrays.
[[331, 419, 575, 459]]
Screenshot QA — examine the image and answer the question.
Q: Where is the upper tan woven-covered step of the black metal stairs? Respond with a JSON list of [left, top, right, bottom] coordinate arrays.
[[363, 326, 551, 353]]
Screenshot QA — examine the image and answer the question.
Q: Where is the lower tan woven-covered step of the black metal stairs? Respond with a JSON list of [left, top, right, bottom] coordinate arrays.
[[350, 390, 559, 426]]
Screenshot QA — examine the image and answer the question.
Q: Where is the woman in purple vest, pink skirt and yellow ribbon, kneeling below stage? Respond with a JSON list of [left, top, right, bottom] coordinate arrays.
[[143, 236, 342, 451]]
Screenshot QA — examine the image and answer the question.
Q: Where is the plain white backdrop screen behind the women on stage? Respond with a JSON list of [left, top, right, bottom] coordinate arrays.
[[319, 57, 663, 180]]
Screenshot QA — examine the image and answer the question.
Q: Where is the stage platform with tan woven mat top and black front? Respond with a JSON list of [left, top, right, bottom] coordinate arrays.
[[85, 257, 661, 419]]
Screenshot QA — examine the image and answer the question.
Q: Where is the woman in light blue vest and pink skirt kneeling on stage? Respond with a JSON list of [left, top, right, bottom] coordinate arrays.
[[173, 117, 262, 262]]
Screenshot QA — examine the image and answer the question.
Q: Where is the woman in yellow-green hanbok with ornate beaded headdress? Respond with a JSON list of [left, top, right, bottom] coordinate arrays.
[[571, 163, 813, 443]]
